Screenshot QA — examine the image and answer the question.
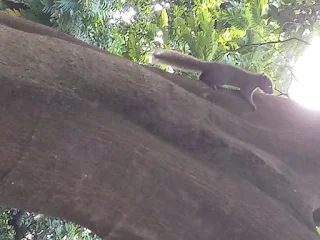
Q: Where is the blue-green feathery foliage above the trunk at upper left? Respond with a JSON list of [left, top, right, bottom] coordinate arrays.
[[0, 0, 114, 44]]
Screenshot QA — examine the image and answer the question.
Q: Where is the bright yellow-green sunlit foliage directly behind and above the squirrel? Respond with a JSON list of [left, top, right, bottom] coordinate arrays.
[[105, 0, 316, 92]]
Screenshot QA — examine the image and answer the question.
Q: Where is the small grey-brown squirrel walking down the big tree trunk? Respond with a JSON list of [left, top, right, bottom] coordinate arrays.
[[151, 49, 273, 111]]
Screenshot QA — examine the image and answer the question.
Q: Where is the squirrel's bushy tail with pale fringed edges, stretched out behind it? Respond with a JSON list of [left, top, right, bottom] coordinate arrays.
[[151, 49, 209, 72]]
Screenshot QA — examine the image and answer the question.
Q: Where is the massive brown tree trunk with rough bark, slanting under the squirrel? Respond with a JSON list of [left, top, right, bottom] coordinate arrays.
[[0, 13, 320, 240]]
